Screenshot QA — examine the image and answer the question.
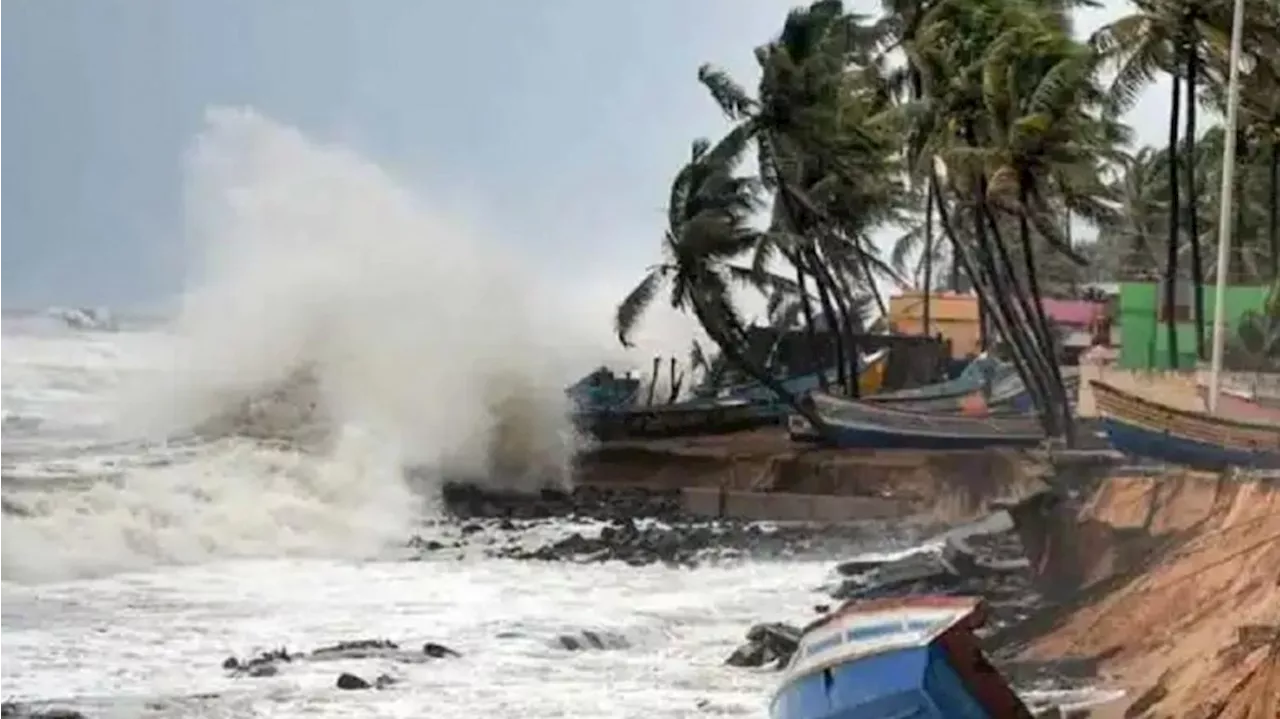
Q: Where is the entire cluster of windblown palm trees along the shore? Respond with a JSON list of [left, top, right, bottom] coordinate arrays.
[[606, 0, 1280, 441]]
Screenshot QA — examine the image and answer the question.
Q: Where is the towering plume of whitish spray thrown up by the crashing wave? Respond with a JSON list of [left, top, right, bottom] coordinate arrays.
[[144, 104, 573, 480]]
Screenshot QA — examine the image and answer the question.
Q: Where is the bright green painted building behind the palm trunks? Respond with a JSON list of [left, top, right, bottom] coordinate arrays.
[[1114, 283, 1270, 370]]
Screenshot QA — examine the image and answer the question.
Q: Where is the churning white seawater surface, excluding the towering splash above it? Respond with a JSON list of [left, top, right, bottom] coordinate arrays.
[[0, 319, 860, 718]]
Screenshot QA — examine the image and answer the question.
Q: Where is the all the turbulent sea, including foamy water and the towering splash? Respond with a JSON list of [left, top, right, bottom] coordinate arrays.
[[0, 111, 885, 718]]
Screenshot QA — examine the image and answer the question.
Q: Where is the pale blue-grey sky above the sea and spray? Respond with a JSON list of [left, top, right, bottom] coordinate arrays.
[[0, 0, 1167, 307]]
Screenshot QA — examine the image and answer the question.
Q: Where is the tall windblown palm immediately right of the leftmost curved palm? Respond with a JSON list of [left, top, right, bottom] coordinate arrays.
[[699, 0, 901, 393]]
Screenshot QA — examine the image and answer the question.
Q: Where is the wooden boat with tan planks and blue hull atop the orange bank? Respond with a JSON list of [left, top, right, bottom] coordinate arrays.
[[1089, 380, 1280, 470]]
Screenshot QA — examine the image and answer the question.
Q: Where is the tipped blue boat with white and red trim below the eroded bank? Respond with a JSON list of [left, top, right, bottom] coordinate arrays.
[[769, 596, 1032, 719]]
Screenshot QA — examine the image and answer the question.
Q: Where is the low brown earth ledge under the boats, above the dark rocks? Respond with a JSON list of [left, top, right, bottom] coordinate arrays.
[[575, 430, 1039, 522]]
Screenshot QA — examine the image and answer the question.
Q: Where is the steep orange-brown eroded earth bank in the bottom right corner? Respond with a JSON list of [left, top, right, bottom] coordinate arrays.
[[1006, 472, 1280, 719]]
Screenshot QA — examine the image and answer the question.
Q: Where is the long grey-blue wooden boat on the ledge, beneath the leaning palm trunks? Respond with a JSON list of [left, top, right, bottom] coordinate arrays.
[[787, 391, 1044, 449]]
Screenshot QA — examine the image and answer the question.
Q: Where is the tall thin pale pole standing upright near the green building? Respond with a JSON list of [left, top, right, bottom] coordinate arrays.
[[1203, 0, 1244, 415]]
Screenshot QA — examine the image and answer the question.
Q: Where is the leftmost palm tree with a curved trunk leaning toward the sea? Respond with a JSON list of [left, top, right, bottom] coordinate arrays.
[[614, 134, 827, 432]]
